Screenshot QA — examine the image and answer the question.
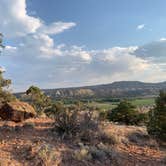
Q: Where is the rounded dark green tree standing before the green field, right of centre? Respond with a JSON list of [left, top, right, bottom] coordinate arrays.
[[109, 100, 138, 125]]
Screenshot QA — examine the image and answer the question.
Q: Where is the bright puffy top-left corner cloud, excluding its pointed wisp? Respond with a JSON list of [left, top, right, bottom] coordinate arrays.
[[0, 0, 42, 37]]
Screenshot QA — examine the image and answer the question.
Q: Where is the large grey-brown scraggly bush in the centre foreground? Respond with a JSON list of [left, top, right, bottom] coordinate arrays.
[[54, 105, 98, 142]]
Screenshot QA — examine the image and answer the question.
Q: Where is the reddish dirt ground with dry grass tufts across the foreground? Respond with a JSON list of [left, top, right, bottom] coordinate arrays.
[[0, 118, 166, 166]]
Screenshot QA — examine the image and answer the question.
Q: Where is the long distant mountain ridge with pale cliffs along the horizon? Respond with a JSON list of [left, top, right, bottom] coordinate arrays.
[[40, 81, 166, 99]]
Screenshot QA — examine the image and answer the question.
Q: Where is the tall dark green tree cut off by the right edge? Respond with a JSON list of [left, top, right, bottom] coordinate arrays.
[[147, 91, 166, 141]]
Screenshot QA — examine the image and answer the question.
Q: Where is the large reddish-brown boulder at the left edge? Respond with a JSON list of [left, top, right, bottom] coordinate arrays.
[[0, 101, 36, 122]]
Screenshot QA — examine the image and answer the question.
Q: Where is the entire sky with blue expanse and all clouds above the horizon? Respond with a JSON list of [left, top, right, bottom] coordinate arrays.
[[0, 0, 166, 92]]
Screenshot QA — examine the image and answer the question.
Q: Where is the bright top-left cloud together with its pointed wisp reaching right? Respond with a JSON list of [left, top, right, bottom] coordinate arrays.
[[0, 0, 75, 37]]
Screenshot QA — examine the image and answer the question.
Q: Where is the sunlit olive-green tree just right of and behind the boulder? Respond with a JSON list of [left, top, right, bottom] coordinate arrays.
[[26, 86, 51, 115]]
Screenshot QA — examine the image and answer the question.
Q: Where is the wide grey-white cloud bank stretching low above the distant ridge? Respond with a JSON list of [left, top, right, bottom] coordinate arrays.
[[1, 43, 166, 90]]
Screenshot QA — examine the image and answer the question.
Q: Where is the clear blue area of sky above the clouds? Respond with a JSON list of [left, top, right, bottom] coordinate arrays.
[[27, 0, 166, 49]]
